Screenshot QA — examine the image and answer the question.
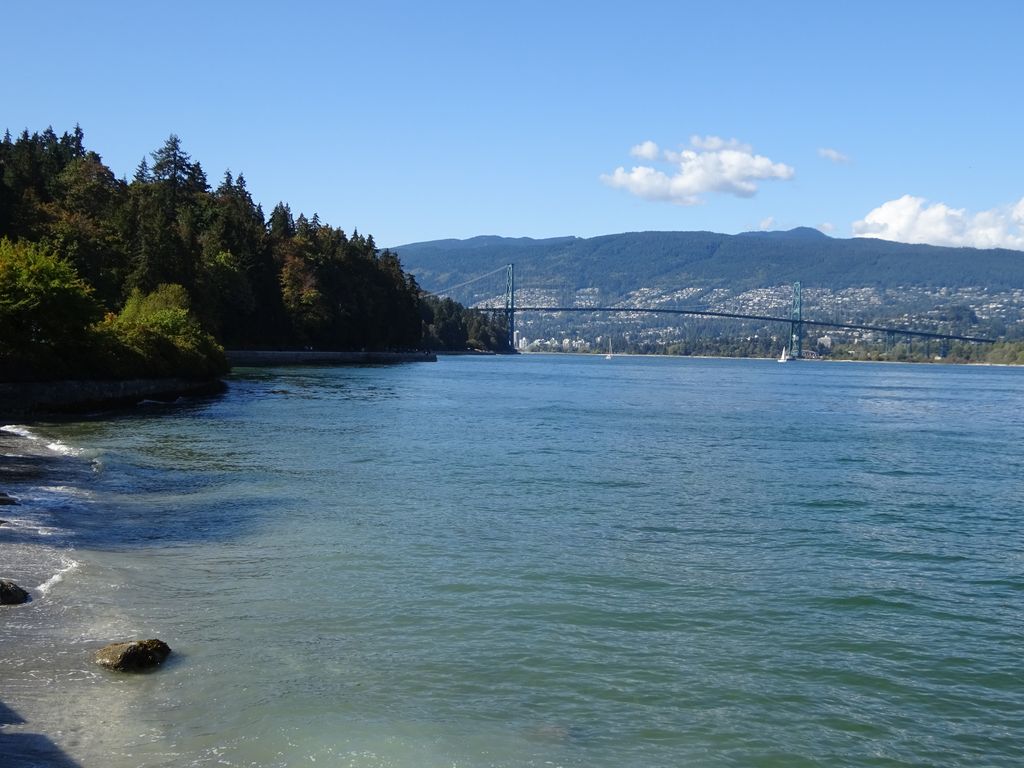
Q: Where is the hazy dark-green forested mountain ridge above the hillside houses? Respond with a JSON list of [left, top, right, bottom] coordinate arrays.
[[394, 227, 1024, 298]]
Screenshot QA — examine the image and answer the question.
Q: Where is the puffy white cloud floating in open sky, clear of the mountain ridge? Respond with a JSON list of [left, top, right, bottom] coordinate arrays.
[[601, 136, 795, 206]]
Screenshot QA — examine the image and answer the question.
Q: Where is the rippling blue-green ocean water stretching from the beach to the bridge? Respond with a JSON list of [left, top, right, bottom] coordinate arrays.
[[0, 355, 1024, 768]]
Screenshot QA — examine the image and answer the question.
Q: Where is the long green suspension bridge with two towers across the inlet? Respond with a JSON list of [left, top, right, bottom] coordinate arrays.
[[425, 264, 995, 357]]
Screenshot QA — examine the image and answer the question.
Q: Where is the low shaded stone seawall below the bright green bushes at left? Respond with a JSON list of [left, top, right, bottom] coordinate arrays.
[[0, 379, 224, 415]]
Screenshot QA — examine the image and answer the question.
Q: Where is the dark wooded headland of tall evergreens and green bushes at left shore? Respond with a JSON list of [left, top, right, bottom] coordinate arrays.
[[0, 127, 504, 378]]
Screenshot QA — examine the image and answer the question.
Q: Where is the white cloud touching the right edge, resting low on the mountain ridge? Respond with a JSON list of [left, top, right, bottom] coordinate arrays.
[[853, 195, 1024, 250]]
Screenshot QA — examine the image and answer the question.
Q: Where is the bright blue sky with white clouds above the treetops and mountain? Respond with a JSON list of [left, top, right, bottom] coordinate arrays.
[[8, 0, 1024, 250]]
